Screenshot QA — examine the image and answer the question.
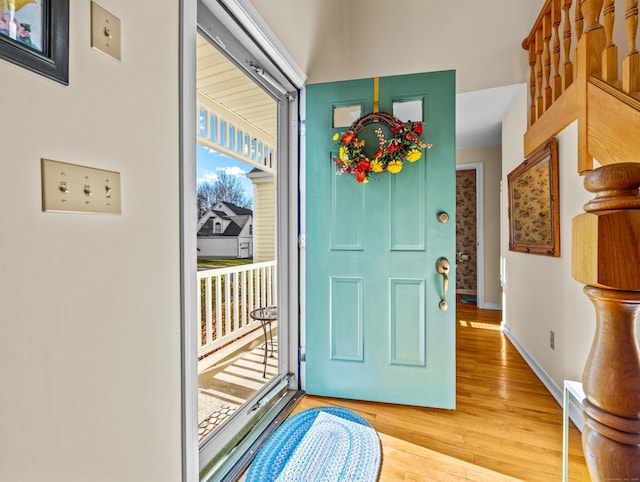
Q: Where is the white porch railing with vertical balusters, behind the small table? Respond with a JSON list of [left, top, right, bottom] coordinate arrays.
[[197, 261, 277, 357]]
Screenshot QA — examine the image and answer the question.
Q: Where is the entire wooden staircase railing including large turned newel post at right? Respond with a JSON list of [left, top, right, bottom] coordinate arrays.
[[523, 0, 640, 481]]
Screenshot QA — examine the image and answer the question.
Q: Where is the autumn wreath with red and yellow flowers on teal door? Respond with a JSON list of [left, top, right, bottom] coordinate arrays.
[[333, 112, 431, 183]]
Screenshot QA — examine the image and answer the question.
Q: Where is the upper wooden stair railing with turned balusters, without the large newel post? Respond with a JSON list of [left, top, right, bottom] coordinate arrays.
[[522, 0, 640, 174]]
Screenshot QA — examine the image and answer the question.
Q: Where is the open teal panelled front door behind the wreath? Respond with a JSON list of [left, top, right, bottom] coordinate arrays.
[[304, 71, 456, 408]]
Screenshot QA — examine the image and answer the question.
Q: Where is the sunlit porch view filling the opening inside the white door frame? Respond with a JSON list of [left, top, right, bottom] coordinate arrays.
[[196, 34, 279, 442]]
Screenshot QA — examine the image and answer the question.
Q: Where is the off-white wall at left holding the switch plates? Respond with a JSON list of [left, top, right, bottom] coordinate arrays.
[[0, 0, 181, 482]]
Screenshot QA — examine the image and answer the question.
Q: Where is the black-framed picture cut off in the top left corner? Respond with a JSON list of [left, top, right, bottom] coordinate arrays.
[[0, 0, 69, 85]]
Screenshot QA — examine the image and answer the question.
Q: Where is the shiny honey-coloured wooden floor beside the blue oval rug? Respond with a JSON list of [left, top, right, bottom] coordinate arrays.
[[296, 303, 589, 482]]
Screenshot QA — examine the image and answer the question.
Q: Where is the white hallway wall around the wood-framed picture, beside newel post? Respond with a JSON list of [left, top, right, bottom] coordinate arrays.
[[501, 87, 595, 387]]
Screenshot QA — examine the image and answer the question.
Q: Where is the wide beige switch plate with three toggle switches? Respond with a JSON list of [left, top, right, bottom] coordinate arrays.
[[42, 159, 122, 214]]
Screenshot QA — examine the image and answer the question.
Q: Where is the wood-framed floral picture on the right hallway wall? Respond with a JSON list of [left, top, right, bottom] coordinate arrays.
[[507, 137, 560, 257]]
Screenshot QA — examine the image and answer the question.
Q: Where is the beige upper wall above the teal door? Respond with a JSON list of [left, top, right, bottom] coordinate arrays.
[[252, 0, 544, 92]]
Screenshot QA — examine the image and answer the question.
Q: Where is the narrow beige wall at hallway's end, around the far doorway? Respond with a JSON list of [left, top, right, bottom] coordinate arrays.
[[456, 146, 502, 308]]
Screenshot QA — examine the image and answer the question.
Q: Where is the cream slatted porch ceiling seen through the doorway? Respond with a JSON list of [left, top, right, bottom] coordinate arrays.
[[196, 35, 277, 139]]
